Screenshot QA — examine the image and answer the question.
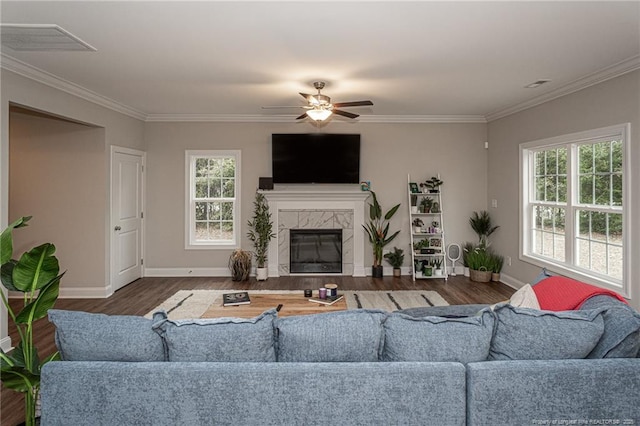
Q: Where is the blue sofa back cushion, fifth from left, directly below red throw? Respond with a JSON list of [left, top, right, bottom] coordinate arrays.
[[489, 304, 604, 360]]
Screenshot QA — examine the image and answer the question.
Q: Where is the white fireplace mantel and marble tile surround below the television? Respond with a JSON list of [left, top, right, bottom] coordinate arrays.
[[263, 188, 369, 277]]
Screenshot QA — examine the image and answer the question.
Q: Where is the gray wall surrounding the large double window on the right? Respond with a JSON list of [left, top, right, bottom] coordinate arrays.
[[488, 71, 640, 308]]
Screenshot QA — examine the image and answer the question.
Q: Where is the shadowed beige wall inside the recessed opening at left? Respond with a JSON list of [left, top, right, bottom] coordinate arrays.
[[9, 112, 108, 295]]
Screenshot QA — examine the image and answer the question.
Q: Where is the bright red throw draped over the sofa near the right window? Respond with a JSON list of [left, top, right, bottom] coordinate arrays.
[[533, 276, 628, 311]]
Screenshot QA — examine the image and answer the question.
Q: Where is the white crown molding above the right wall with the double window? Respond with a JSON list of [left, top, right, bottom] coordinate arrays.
[[485, 55, 640, 122]]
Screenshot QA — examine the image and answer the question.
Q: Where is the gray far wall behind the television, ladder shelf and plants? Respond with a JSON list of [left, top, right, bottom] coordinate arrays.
[[145, 122, 487, 272]]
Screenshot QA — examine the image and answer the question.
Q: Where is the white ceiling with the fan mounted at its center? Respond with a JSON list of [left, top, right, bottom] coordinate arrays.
[[0, 0, 640, 121]]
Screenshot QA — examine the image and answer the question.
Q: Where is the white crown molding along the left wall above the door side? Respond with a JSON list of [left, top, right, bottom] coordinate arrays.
[[0, 52, 147, 120]]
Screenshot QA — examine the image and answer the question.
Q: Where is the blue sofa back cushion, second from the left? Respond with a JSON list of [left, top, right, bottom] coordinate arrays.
[[153, 309, 276, 362]]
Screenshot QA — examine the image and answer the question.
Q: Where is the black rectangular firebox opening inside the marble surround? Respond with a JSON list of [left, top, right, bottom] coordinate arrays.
[[289, 229, 342, 274]]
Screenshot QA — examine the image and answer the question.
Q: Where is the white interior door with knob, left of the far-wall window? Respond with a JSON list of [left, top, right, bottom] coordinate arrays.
[[111, 150, 144, 291]]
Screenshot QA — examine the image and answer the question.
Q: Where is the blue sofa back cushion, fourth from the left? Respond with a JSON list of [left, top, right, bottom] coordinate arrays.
[[382, 308, 494, 364]]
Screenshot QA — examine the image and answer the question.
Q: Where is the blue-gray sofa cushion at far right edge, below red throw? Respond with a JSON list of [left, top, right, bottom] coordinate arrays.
[[580, 296, 640, 358]]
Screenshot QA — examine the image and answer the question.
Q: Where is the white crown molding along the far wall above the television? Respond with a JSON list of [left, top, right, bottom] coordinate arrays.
[[145, 114, 487, 123]]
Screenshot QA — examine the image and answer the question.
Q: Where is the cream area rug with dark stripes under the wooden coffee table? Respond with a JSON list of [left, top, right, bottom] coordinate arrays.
[[145, 290, 449, 319]]
